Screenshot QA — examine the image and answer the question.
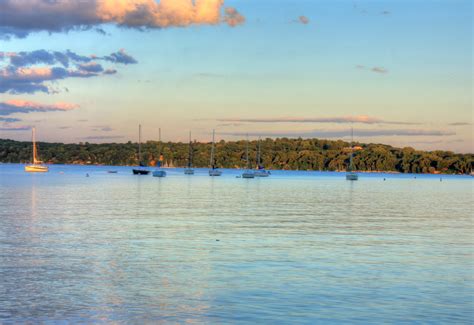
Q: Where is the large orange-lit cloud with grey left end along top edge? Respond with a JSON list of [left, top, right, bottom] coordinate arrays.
[[0, 0, 245, 39]]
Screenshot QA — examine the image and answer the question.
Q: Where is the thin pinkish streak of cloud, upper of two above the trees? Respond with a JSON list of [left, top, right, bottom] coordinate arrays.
[[217, 115, 419, 125]]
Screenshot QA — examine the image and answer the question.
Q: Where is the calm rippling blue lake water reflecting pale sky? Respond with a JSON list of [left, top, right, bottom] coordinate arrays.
[[0, 165, 474, 324]]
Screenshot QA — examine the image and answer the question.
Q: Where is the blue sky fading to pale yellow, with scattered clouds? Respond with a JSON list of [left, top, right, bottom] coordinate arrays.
[[0, 0, 474, 153]]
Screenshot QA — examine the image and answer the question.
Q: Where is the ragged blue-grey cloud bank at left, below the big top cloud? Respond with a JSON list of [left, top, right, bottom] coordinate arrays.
[[0, 49, 137, 94]]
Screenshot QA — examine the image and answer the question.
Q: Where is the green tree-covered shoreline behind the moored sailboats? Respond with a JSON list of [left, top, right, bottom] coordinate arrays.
[[0, 138, 474, 174]]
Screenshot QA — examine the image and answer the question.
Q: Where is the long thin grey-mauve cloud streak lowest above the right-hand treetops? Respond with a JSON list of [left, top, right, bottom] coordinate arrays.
[[220, 129, 456, 138]]
